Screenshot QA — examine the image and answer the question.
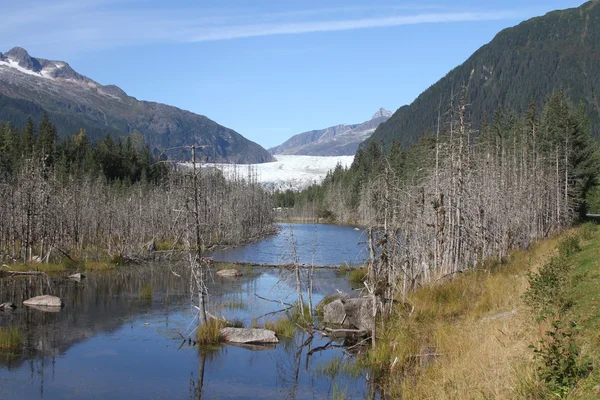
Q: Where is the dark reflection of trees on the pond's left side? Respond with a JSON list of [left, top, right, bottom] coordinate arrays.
[[0, 266, 188, 367]]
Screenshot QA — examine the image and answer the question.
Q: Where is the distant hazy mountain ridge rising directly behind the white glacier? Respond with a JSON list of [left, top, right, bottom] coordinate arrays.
[[269, 108, 392, 156]]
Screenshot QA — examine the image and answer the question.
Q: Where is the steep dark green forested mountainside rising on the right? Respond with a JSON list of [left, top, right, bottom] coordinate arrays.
[[365, 0, 600, 150]]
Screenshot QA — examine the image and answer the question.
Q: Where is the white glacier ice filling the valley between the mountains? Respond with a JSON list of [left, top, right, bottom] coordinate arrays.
[[202, 155, 354, 190]]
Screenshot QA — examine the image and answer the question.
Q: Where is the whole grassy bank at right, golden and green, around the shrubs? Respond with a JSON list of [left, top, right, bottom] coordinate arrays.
[[368, 224, 600, 399]]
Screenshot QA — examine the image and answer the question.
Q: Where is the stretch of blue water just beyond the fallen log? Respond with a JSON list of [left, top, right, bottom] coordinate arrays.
[[210, 224, 368, 265]]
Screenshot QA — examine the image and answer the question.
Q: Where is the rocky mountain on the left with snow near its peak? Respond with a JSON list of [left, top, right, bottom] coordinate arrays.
[[0, 47, 274, 163]]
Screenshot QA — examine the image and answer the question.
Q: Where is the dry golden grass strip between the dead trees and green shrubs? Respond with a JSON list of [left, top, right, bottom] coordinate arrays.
[[370, 230, 557, 399]]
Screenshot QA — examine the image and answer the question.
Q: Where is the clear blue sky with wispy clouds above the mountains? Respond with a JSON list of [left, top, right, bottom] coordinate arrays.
[[0, 0, 583, 147]]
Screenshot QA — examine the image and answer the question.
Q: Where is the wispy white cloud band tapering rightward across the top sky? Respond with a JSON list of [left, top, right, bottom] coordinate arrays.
[[0, 0, 526, 54]]
